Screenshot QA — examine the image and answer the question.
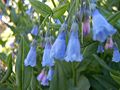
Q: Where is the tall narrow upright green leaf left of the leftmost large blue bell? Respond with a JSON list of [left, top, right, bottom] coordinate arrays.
[[16, 36, 31, 90]]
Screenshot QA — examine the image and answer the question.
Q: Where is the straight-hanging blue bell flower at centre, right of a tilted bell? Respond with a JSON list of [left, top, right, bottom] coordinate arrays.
[[65, 22, 83, 62]]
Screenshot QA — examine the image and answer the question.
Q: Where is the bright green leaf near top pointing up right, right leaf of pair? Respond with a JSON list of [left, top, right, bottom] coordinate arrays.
[[53, 3, 69, 18]]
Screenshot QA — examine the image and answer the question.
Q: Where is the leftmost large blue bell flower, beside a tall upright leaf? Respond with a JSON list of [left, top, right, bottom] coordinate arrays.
[[24, 40, 37, 67]]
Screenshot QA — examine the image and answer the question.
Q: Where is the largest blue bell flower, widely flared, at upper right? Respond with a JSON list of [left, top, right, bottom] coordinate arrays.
[[92, 9, 116, 42]]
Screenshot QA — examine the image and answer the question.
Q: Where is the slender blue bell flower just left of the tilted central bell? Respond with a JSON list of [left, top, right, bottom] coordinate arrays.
[[42, 39, 54, 67]]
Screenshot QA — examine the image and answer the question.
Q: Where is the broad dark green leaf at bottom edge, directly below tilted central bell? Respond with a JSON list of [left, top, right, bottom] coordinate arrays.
[[50, 62, 67, 90]]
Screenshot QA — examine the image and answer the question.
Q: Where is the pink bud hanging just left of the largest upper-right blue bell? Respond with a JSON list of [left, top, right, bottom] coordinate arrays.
[[82, 18, 90, 36]]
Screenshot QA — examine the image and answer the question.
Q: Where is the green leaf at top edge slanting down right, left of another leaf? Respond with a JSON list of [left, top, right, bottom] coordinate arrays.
[[29, 0, 52, 17]]
